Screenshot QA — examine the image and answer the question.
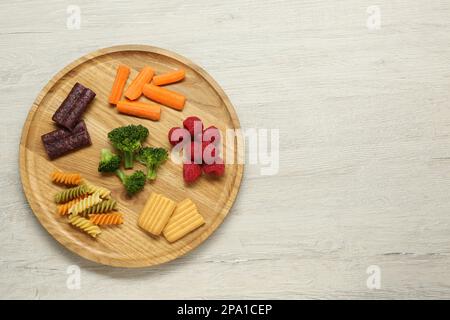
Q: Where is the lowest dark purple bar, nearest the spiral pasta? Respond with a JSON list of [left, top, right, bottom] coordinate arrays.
[[44, 131, 91, 159]]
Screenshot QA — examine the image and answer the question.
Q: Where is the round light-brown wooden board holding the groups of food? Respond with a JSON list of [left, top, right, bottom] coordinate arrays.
[[20, 45, 243, 267]]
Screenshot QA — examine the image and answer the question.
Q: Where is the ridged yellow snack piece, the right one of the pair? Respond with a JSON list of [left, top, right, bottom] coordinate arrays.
[[163, 199, 205, 242]]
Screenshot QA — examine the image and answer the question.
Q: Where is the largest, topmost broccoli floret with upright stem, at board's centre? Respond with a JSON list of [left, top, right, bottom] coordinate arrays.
[[108, 124, 148, 169]]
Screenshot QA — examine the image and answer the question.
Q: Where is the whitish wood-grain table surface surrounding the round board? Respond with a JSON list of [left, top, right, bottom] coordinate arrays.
[[0, 0, 450, 299]]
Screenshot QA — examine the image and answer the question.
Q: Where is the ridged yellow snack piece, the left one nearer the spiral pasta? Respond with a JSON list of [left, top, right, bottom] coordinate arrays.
[[138, 192, 176, 236]]
